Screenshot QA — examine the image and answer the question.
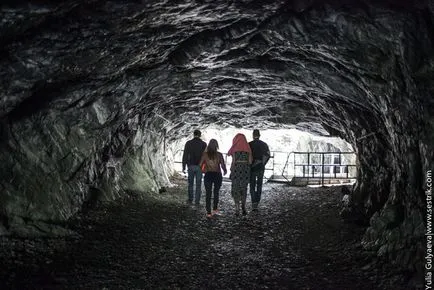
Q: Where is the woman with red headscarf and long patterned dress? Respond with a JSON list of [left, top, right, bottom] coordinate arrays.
[[228, 134, 252, 215]]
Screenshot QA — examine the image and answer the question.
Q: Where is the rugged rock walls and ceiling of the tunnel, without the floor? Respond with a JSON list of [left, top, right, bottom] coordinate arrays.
[[0, 0, 434, 288]]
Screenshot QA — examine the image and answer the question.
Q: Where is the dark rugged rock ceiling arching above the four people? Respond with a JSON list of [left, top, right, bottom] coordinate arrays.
[[0, 1, 433, 140]]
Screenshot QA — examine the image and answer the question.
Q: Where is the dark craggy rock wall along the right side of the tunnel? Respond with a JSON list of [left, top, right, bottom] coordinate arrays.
[[318, 53, 434, 273]]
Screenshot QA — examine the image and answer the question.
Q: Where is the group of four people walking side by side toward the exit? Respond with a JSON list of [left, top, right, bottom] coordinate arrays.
[[182, 129, 270, 217]]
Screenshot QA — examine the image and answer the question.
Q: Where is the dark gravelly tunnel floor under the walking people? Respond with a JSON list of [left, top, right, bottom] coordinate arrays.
[[0, 176, 412, 289]]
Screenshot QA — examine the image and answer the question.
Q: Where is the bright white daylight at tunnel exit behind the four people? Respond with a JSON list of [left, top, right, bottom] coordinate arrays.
[[173, 127, 357, 184]]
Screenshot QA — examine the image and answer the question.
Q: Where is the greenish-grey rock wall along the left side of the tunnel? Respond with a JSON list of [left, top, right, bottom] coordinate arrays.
[[0, 103, 172, 236]]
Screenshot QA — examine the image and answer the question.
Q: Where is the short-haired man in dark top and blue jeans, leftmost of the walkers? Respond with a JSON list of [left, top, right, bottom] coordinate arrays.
[[182, 130, 206, 205]]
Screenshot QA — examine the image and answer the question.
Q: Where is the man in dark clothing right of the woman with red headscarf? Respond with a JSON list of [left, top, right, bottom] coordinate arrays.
[[249, 129, 270, 210]]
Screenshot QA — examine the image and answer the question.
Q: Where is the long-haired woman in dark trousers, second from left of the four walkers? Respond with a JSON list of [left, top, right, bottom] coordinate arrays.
[[199, 139, 227, 217]]
